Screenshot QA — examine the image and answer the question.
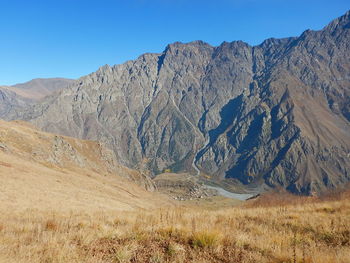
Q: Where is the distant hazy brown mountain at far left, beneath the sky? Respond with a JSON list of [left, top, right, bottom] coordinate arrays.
[[0, 78, 74, 119]]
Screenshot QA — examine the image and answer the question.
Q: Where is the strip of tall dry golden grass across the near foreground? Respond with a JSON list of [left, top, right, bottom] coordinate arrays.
[[0, 195, 350, 263]]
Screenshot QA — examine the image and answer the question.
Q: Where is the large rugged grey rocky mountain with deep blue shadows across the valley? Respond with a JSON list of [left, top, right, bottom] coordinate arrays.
[[9, 12, 350, 194]]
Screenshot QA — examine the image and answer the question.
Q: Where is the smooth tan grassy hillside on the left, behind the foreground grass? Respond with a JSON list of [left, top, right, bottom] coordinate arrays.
[[0, 121, 164, 211]]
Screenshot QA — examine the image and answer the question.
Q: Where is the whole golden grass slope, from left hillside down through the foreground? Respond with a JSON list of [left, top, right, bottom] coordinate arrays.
[[0, 122, 350, 263]]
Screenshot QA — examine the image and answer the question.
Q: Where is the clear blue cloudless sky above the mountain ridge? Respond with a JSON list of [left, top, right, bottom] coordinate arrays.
[[0, 0, 350, 85]]
